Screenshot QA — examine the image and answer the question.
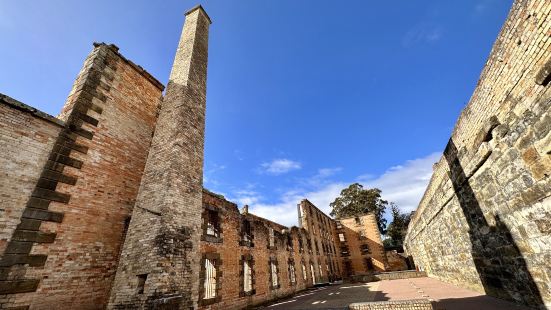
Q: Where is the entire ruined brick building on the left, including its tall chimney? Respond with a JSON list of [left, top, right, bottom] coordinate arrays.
[[0, 6, 388, 309]]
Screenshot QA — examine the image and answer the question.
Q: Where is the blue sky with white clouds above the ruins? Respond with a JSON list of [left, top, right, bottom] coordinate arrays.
[[0, 0, 511, 225]]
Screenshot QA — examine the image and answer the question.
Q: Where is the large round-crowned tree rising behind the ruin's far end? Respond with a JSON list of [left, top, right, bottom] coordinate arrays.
[[329, 183, 388, 234]]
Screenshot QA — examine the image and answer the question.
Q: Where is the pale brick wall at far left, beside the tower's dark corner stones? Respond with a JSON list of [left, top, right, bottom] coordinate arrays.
[[0, 94, 63, 254]]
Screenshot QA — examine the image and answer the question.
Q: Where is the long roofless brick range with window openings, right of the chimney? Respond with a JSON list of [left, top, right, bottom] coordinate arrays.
[[199, 190, 398, 309]]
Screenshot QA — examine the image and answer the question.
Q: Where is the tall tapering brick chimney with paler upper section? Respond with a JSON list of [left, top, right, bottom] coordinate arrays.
[[109, 5, 211, 309]]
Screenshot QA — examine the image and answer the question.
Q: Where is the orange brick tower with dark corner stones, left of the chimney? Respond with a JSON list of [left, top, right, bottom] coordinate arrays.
[[0, 44, 163, 309]]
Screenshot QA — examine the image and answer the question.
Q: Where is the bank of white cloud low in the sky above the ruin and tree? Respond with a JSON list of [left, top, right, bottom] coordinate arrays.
[[239, 153, 441, 226]]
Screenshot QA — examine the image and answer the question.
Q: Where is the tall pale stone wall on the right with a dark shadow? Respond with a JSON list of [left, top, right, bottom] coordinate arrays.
[[405, 0, 551, 308]]
